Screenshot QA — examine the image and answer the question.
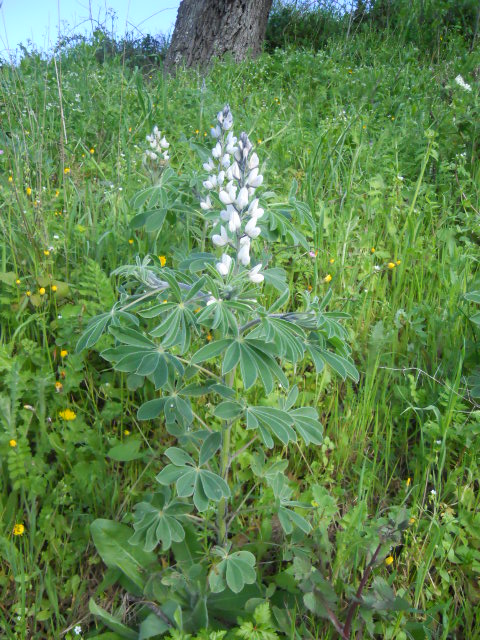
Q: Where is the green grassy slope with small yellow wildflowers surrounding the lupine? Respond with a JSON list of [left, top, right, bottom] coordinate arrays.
[[0, 23, 480, 639]]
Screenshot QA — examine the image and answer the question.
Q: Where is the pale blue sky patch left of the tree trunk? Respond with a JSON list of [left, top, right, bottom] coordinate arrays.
[[0, 0, 180, 57]]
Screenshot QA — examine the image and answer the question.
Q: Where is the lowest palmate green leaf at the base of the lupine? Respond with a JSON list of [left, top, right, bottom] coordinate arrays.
[[208, 547, 257, 593]]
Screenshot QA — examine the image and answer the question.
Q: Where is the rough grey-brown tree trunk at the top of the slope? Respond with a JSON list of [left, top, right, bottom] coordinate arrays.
[[165, 0, 272, 71]]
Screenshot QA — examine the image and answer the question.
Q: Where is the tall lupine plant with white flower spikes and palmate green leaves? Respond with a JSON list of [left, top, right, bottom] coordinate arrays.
[[77, 105, 358, 637]]
